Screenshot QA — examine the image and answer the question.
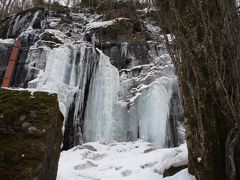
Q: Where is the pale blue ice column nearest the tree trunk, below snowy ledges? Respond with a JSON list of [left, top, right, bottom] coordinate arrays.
[[130, 76, 176, 148]]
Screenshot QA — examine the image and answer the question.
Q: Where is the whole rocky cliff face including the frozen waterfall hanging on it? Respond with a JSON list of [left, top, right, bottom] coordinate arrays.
[[0, 1, 184, 149]]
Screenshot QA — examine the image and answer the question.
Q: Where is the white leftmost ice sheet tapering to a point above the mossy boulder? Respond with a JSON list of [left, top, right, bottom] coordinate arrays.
[[29, 46, 76, 117]]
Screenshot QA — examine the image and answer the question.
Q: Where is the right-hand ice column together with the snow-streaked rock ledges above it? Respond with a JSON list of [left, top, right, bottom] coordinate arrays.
[[118, 60, 178, 148]]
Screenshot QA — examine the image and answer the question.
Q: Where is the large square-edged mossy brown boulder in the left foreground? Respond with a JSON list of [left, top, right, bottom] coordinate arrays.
[[0, 90, 63, 180]]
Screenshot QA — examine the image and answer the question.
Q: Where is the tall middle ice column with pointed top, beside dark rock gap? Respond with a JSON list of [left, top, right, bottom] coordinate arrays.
[[84, 51, 124, 143]]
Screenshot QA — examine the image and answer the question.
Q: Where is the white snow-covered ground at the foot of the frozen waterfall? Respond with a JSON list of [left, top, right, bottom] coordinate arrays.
[[57, 141, 195, 180]]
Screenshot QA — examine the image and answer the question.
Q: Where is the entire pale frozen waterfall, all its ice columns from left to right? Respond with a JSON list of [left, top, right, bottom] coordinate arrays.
[[21, 39, 183, 148]]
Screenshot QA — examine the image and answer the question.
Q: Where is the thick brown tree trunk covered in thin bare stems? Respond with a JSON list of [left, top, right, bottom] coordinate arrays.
[[160, 0, 240, 180]]
